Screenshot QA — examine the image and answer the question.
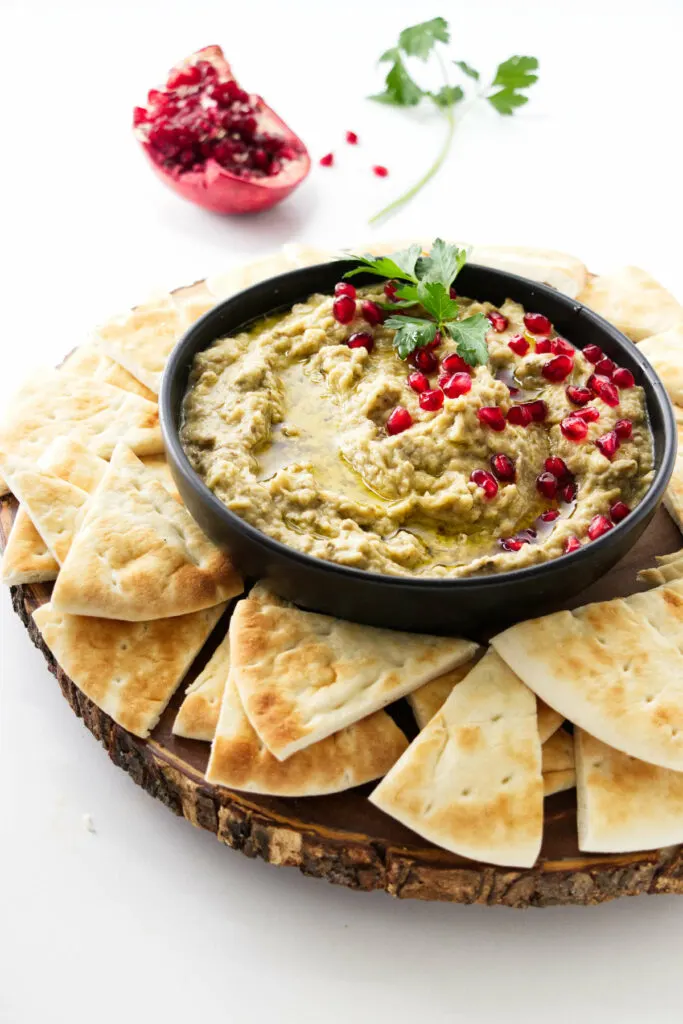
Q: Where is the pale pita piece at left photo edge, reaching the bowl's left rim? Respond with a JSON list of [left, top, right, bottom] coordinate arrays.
[[0, 370, 164, 493]]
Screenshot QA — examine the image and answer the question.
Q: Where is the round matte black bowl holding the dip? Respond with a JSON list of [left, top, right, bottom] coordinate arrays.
[[160, 261, 676, 633]]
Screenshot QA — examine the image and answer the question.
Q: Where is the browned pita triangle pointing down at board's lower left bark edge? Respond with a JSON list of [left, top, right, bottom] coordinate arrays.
[[33, 604, 225, 736]]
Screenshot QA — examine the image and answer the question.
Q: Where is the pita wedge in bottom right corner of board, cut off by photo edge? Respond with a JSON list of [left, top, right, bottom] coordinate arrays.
[[574, 729, 683, 853]]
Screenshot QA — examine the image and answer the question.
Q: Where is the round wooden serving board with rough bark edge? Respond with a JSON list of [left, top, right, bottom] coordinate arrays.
[[0, 497, 683, 907]]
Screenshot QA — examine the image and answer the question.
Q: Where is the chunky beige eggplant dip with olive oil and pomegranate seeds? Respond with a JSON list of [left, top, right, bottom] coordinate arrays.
[[181, 285, 653, 578]]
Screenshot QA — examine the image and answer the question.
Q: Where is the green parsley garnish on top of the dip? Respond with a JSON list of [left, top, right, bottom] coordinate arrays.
[[344, 239, 490, 367]]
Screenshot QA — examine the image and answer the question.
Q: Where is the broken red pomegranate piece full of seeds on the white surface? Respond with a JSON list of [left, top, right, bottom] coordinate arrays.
[[133, 46, 310, 213]]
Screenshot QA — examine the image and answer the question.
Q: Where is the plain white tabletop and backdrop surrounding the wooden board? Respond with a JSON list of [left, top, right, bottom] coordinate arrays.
[[0, 0, 683, 1024]]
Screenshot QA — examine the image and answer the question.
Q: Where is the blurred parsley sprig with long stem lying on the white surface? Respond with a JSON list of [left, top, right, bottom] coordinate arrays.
[[370, 17, 539, 223]]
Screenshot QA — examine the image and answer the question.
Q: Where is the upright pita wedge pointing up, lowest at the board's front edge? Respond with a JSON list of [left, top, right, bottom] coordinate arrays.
[[370, 650, 544, 867]]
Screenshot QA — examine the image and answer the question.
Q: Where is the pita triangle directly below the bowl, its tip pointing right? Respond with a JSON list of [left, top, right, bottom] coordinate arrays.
[[230, 584, 477, 761]]
